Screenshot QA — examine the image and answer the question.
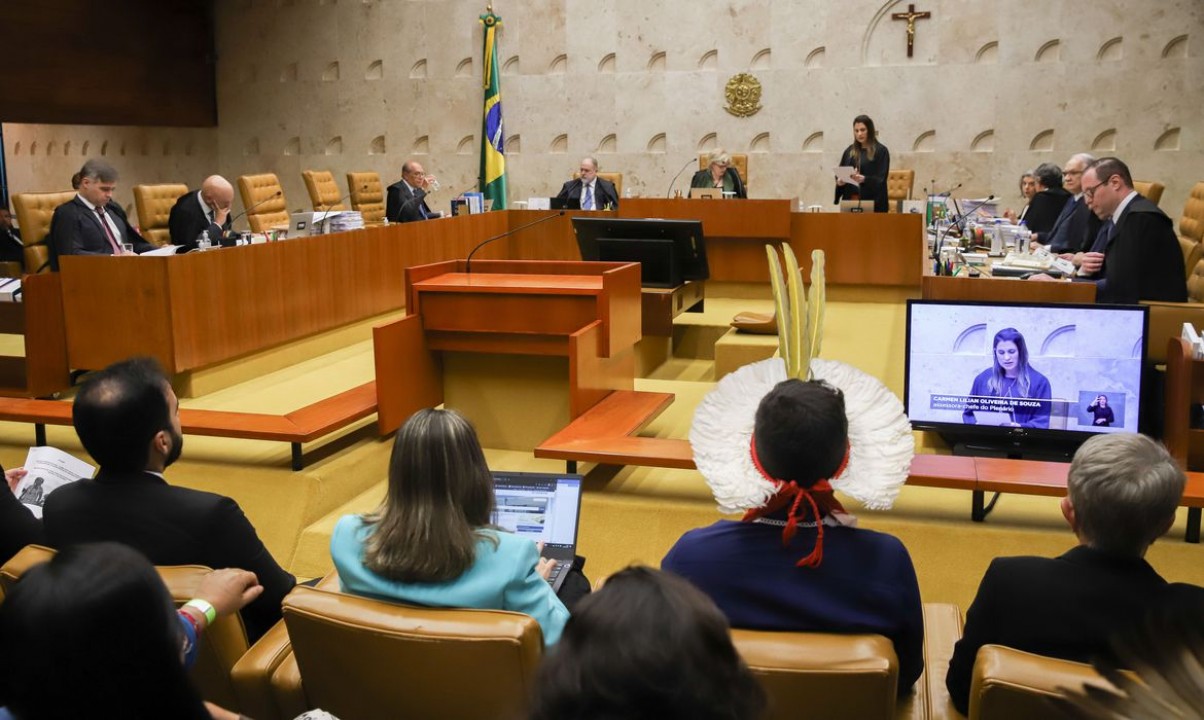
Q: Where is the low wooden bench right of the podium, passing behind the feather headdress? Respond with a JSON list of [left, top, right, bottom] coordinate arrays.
[[535, 404, 1204, 543]]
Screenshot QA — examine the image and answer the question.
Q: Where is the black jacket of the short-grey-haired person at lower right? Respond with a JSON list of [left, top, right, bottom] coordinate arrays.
[[945, 545, 1167, 713]]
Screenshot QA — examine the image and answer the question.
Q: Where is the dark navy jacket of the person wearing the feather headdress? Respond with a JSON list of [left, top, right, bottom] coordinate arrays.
[[661, 520, 923, 695]]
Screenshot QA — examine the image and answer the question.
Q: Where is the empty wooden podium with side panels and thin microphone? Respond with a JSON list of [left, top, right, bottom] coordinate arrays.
[[373, 260, 641, 450]]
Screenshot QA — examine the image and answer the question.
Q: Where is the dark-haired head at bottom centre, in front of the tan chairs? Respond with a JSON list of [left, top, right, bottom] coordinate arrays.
[[530, 567, 766, 720]]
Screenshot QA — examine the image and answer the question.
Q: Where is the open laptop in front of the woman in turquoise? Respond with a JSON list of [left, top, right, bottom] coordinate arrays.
[[490, 472, 582, 591]]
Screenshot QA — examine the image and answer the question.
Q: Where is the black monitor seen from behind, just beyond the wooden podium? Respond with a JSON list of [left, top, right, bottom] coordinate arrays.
[[573, 217, 710, 288]]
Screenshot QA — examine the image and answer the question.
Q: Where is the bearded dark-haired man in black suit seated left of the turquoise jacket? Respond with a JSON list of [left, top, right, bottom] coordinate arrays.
[[42, 359, 296, 641]]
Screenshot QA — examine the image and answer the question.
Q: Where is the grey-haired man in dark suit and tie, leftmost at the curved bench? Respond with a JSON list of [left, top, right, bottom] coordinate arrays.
[[48, 159, 154, 270]]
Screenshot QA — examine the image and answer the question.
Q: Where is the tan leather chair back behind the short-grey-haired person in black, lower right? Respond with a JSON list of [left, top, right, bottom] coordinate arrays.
[[969, 645, 1108, 720]]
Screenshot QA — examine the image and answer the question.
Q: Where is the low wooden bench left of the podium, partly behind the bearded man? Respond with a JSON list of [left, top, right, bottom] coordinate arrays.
[[0, 382, 377, 470]]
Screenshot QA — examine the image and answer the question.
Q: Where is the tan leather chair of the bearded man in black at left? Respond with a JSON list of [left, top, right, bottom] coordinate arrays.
[[0, 545, 247, 709]]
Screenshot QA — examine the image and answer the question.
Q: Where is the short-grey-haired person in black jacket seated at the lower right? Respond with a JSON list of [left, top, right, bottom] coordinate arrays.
[[945, 433, 1186, 713]]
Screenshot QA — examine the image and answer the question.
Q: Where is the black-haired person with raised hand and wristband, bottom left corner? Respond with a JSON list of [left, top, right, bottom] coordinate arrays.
[[0, 543, 262, 720]]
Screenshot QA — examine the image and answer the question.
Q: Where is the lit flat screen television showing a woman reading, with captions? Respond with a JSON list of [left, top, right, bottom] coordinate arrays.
[[903, 300, 1149, 460]]
